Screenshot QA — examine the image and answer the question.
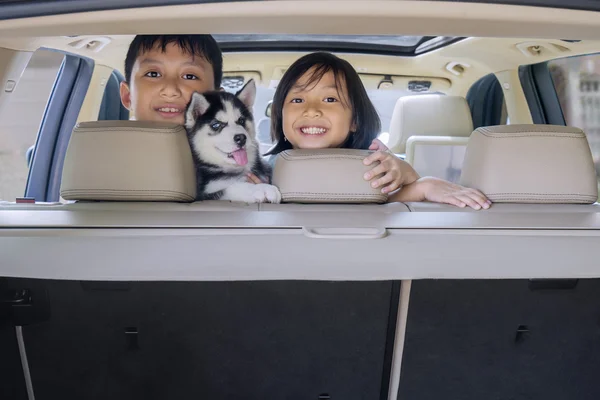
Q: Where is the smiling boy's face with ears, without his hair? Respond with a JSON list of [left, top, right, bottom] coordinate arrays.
[[121, 43, 215, 124]]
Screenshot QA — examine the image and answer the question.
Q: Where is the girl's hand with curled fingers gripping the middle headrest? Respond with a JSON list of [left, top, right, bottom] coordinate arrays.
[[363, 139, 419, 193]]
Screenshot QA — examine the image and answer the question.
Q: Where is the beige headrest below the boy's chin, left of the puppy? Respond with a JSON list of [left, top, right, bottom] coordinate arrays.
[[60, 121, 196, 202]]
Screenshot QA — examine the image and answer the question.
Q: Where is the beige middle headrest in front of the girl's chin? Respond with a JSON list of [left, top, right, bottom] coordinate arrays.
[[273, 149, 387, 203]]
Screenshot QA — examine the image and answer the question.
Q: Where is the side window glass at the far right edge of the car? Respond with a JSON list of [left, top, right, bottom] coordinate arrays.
[[548, 55, 600, 188]]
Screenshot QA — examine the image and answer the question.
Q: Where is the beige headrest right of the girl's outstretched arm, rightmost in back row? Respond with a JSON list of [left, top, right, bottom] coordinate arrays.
[[460, 125, 598, 203]]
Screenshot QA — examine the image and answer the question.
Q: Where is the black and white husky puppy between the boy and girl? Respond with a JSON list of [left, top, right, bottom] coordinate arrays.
[[185, 80, 281, 203]]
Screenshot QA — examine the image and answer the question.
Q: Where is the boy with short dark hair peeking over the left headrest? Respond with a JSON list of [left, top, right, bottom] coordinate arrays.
[[120, 35, 223, 125]]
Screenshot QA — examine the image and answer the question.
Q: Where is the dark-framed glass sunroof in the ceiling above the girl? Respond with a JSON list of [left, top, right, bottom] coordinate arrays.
[[213, 34, 463, 56]]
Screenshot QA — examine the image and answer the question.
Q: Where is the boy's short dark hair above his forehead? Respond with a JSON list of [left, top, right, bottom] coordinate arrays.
[[125, 35, 223, 89]]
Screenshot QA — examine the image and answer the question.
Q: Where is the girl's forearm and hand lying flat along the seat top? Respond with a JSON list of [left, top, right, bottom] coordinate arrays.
[[389, 176, 492, 210]]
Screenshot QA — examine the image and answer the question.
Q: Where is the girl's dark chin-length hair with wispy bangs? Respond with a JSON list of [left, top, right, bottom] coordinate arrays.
[[266, 52, 381, 155]]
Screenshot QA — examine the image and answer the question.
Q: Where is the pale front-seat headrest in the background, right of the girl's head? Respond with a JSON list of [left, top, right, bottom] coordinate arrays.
[[388, 94, 473, 153]]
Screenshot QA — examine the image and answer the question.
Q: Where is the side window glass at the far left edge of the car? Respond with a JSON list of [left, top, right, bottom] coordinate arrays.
[[0, 49, 64, 201]]
